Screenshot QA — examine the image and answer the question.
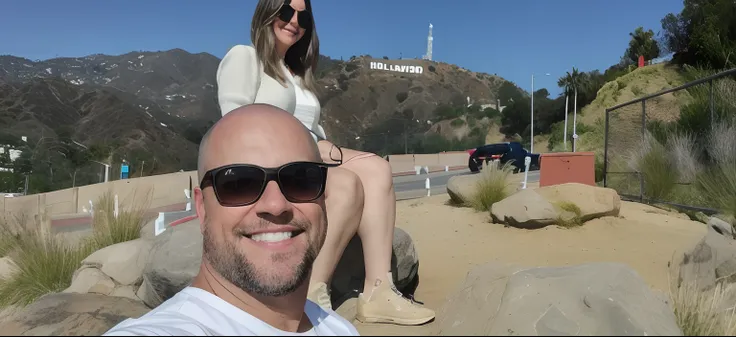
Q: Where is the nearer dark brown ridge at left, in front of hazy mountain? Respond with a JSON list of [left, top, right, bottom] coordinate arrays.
[[0, 78, 197, 172]]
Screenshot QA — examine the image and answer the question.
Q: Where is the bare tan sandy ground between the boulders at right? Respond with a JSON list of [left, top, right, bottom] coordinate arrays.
[[344, 194, 707, 335]]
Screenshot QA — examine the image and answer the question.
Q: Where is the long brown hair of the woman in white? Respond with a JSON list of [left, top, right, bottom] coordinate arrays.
[[250, 0, 319, 93]]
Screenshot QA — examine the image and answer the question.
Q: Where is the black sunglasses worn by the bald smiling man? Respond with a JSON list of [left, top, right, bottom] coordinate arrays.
[[199, 161, 340, 207]]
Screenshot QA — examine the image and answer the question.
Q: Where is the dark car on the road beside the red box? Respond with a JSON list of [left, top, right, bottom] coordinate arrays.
[[468, 142, 539, 173]]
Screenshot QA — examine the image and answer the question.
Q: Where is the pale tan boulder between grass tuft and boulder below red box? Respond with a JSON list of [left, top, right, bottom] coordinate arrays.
[[491, 189, 557, 229]]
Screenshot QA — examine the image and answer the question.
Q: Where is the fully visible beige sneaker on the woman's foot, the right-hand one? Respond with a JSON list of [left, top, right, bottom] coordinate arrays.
[[355, 281, 435, 325]]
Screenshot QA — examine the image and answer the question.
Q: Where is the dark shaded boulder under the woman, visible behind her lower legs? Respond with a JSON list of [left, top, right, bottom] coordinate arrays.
[[331, 228, 419, 304]]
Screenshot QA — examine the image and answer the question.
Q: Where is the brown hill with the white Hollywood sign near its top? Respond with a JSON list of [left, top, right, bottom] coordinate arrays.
[[319, 56, 505, 148]]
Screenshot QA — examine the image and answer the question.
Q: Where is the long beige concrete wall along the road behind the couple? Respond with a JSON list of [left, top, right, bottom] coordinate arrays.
[[0, 151, 468, 226]]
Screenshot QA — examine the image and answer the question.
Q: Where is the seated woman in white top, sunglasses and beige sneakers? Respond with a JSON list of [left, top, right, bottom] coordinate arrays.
[[217, 0, 435, 325]]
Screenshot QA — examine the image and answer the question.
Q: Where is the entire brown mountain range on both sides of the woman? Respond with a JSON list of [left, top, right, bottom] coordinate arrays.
[[0, 49, 526, 193]]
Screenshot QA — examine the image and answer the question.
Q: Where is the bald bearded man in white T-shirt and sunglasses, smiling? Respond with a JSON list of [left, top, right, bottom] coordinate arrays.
[[105, 104, 358, 336]]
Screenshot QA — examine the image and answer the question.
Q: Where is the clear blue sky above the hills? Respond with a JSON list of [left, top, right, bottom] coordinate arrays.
[[0, 0, 683, 96]]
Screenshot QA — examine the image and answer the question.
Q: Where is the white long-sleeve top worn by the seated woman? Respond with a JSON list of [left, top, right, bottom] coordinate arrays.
[[217, 45, 327, 141]]
